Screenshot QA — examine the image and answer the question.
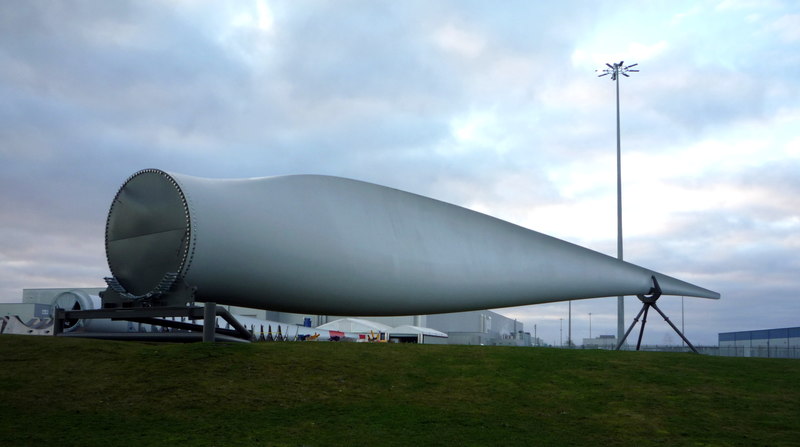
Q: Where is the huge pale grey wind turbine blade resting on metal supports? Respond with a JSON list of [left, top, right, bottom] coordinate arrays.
[[104, 169, 719, 316]]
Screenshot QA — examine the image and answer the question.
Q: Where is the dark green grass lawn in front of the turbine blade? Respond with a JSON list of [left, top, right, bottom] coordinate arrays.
[[0, 335, 800, 447]]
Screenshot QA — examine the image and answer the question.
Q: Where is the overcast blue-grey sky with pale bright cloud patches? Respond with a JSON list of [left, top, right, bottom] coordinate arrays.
[[0, 0, 800, 345]]
